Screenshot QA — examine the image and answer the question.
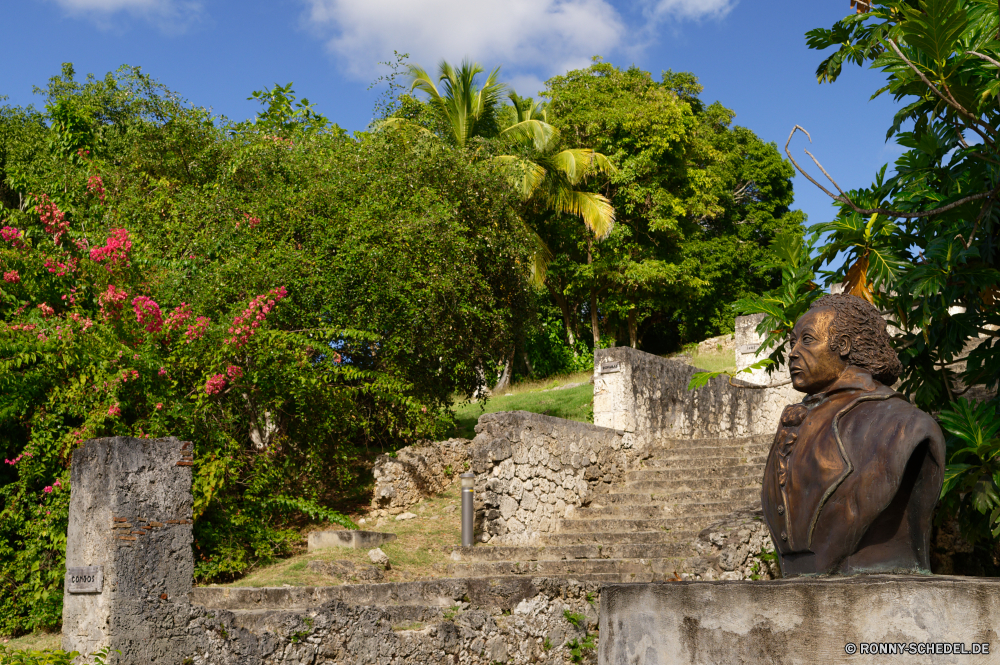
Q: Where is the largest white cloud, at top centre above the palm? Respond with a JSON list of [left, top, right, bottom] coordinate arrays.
[[300, 0, 626, 81]]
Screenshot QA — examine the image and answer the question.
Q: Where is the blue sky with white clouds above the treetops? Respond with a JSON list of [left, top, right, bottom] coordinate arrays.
[[0, 0, 899, 232]]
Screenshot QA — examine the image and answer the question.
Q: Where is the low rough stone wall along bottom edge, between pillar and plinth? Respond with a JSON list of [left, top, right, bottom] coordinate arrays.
[[178, 578, 600, 665]]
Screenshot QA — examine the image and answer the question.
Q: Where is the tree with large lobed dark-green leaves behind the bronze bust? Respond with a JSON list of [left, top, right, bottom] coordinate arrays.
[[740, 0, 1000, 571]]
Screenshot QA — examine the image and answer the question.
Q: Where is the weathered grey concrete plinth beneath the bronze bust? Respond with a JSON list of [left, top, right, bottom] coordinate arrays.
[[599, 575, 1000, 665]]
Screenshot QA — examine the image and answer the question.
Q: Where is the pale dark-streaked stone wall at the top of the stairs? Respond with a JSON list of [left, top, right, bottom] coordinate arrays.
[[594, 346, 802, 447]]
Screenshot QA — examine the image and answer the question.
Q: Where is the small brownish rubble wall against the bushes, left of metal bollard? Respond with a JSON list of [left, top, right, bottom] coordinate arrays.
[[372, 439, 471, 517]]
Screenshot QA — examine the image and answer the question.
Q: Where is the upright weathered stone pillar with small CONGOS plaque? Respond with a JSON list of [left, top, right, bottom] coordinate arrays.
[[63, 437, 194, 663]]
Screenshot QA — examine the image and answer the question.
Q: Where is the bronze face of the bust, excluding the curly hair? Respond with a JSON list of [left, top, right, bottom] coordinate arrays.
[[788, 307, 851, 395]]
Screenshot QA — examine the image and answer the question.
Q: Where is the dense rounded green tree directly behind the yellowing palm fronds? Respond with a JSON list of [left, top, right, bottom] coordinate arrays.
[[532, 60, 802, 350]]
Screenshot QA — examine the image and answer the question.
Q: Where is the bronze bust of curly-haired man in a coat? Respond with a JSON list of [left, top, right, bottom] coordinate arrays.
[[761, 295, 945, 577]]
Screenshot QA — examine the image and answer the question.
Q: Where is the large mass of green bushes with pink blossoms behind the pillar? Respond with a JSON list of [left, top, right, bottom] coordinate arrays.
[[0, 66, 530, 634]]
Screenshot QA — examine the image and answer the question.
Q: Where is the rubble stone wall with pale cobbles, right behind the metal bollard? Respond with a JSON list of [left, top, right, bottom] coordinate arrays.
[[472, 411, 636, 545]]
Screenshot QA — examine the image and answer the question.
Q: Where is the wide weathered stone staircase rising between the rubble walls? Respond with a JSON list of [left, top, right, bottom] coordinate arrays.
[[447, 435, 772, 582]]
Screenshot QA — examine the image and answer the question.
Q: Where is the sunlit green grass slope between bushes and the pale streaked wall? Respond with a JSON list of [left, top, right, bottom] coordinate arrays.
[[453, 372, 594, 439]]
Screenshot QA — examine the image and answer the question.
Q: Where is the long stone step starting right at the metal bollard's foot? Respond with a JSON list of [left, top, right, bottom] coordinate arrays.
[[451, 534, 694, 562]]
